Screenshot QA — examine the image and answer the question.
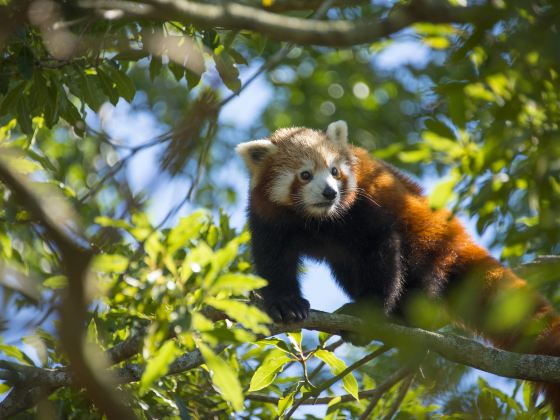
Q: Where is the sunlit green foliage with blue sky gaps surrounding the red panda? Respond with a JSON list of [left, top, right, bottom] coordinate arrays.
[[0, 0, 560, 419]]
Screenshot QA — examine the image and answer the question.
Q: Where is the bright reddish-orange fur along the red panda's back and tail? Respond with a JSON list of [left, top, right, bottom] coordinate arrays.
[[353, 148, 560, 416]]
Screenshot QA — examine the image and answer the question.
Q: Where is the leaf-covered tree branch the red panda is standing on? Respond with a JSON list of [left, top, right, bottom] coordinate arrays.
[[5, 311, 560, 414]]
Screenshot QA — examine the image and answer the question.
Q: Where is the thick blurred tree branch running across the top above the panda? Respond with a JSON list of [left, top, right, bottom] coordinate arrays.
[[79, 0, 501, 47]]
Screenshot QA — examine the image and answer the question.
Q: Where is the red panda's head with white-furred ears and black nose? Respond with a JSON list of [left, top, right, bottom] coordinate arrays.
[[236, 121, 356, 219]]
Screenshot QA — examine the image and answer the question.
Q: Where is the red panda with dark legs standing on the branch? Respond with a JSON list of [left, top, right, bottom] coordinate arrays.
[[236, 121, 560, 414]]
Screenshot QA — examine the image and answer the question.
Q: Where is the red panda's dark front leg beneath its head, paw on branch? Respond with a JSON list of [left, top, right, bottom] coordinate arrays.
[[249, 217, 310, 322]]
